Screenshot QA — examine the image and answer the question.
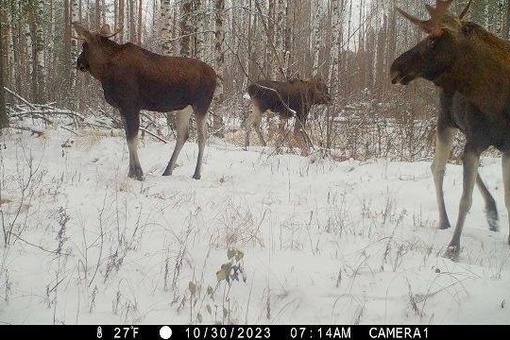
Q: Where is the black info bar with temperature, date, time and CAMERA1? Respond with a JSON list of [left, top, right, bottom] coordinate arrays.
[[0, 324, 510, 340]]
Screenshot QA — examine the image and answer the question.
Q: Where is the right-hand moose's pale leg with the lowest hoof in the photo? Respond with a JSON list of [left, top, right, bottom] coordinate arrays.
[[445, 145, 480, 259]]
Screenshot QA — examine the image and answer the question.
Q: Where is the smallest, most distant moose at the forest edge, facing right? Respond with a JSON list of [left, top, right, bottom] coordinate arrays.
[[244, 79, 332, 149]]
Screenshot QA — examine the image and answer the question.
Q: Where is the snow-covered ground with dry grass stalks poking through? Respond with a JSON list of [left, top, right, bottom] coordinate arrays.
[[0, 129, 510, 324]]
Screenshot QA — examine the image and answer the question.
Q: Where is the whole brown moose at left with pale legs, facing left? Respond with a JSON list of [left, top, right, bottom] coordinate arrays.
[[73, 22, 216, 180]]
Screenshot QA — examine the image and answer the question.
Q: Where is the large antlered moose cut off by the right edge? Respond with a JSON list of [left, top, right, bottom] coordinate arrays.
[[390, 0, 510, 260]]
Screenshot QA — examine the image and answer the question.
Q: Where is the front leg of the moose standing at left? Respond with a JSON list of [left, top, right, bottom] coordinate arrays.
[[121, 112, 143, 181]]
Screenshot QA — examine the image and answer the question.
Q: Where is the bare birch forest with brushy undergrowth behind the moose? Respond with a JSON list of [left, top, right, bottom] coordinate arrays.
[[0, 0, 510, 160]]
